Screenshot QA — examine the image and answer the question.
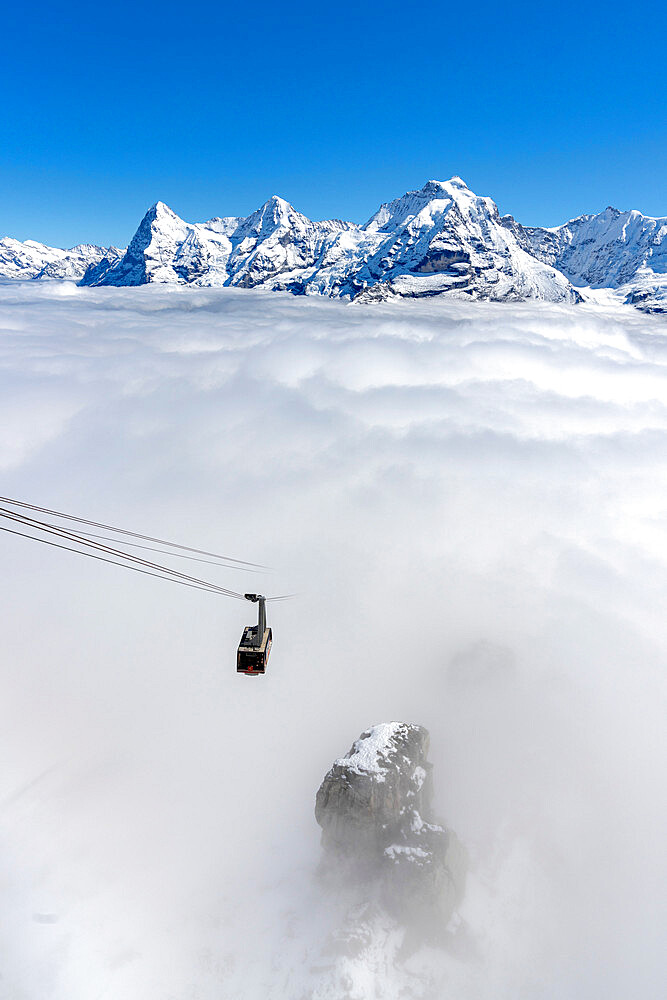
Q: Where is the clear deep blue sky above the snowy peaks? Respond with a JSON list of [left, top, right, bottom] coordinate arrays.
[[0, 0, 667, 246]]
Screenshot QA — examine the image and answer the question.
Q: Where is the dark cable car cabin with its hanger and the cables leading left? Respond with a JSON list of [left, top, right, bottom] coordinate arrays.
[[0, 497, 294, 677]]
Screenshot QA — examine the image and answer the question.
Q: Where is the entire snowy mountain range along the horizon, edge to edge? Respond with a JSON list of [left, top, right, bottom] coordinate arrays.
[[0, 177, 667, 312]]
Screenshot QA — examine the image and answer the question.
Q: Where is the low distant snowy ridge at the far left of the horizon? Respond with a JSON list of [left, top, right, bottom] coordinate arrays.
[[0, 236, 123, 281]]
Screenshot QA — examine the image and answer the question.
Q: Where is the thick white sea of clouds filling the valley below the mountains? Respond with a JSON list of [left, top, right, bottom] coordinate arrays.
[[0, 283, 667, 1000]]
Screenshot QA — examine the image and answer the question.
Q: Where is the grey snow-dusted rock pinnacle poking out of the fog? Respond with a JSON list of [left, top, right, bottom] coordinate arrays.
[[315, 722, 467, 936]]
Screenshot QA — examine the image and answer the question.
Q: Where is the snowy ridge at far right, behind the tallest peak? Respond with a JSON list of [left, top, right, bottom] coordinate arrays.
[[502, 206, 667, 312]]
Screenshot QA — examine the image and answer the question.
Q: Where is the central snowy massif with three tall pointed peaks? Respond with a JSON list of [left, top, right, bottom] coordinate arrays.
[[83, 177, 578, 302]]
